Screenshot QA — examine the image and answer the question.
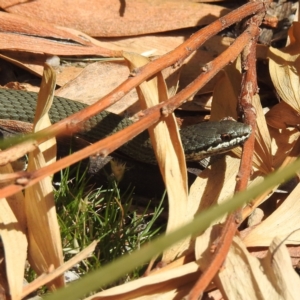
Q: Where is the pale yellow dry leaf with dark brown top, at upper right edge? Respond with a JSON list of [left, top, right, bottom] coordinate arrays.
[[268, 22, 300, 113]]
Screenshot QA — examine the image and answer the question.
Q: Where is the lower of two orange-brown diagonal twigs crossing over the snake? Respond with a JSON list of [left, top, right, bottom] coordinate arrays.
[[0, 25, 262, 197]]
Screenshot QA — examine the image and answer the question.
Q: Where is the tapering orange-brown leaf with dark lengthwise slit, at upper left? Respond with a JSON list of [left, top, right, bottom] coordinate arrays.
[[0, 11, 122, 57]]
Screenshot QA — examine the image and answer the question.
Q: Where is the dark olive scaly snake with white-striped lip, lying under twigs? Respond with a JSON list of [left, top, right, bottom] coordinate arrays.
[[0, 89, 251, 164]]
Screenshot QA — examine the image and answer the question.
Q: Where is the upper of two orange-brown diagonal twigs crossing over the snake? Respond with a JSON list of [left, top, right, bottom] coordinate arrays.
[[0, 2, 264, 166]]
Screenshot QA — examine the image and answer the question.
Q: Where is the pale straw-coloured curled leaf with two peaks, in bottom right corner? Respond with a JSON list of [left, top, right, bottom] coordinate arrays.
[[216, 237, 300, 300]]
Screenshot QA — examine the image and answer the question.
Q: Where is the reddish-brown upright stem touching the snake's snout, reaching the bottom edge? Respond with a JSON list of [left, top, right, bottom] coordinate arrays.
[[188, 14, 263, 300]]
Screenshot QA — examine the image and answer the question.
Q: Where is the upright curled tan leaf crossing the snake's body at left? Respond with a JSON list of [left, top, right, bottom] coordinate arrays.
[[25, 65, 64, 289]]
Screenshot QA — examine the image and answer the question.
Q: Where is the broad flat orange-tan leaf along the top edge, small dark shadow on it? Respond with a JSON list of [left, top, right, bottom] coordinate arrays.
[[0, 0, 229, 37]]
